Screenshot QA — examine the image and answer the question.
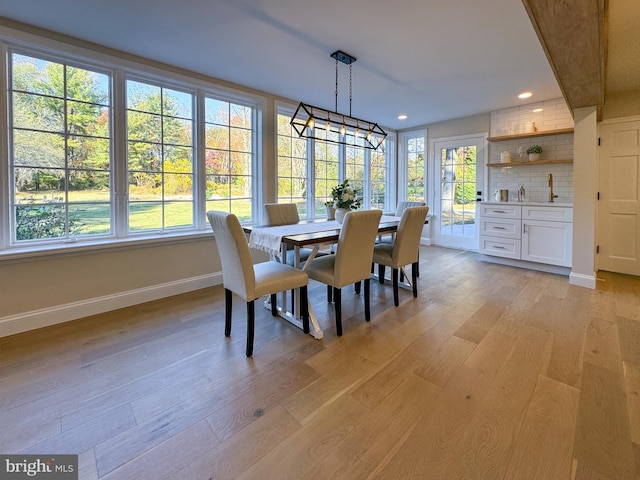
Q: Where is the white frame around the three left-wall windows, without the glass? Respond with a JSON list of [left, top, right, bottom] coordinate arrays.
[[0, 31, 266, 261]]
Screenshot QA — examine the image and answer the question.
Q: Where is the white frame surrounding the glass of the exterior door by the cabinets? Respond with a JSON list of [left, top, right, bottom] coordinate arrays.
[[427, 132, 489, 251]]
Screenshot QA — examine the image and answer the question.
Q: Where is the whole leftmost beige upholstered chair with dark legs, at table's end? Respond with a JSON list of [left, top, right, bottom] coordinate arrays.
[[207, 210, 309, 357]]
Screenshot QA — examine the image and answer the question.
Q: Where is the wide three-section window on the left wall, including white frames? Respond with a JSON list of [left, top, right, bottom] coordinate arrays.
[[0, 40, 258, 255]]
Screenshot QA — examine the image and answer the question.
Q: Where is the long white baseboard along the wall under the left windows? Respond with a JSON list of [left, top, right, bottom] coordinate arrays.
[[0, 272, 222, 337]]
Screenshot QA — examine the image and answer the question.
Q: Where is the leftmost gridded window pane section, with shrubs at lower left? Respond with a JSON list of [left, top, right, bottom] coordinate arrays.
[[10, 53, 112, 243]]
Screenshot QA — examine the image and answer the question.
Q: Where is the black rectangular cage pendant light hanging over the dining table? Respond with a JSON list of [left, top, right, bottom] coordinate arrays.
[[290, 50, 387, 150]]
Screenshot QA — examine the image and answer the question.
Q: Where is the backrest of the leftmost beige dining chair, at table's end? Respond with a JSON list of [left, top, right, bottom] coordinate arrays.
[[207, 210, 256, 301]]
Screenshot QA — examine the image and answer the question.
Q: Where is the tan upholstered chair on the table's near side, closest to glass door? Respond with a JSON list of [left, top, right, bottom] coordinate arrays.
[[373, 206, 429, 307]]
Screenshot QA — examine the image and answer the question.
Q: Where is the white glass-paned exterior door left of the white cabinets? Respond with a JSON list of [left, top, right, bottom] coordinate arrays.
[[432, 135, 487, 250]]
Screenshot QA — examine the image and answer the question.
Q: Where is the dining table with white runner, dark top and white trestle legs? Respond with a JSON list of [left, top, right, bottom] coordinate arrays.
[[243, 215, 400, 339]]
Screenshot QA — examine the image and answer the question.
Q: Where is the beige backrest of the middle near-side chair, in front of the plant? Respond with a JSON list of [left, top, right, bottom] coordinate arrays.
[[333, 210, 382, 288]]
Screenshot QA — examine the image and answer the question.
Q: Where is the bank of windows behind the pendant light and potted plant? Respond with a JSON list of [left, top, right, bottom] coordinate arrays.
[[277, 108, 393, 218]]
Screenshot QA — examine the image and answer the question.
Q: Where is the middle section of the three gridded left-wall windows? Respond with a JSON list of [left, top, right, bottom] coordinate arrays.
[[127, 80, 194, 232]]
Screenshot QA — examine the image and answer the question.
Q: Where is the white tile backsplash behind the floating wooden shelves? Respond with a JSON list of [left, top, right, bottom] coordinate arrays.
[[485, 98, 573, 202]]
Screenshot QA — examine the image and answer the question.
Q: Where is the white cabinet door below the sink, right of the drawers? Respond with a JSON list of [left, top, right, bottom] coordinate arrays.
[[520, 206, 573, 267]]
